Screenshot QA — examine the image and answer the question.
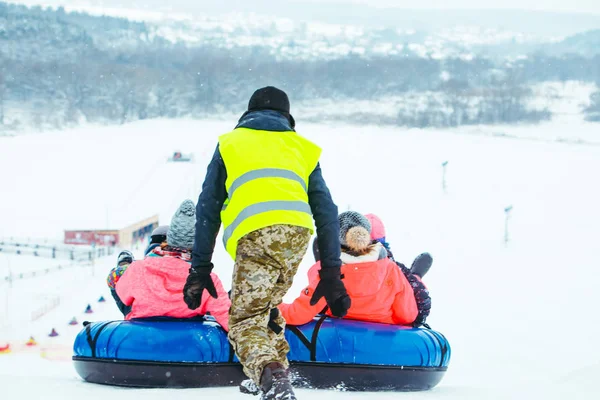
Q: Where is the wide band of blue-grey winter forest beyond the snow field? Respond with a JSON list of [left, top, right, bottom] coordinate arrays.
[[0, 3, 600, 130]]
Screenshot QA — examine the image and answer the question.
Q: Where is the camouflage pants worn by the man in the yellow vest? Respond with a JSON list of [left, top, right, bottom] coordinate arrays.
[[228, 225, 310, 384]]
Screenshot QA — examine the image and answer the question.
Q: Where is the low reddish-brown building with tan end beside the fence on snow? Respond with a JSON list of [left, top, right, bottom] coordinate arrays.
[[65, 215, 158, 248]]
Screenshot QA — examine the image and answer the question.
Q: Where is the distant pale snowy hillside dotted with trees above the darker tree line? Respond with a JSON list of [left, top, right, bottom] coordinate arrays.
[[7, 1, 600, 59]]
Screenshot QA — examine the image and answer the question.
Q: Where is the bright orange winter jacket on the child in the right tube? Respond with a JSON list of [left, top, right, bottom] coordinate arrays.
[[279, 247, 418, 325]]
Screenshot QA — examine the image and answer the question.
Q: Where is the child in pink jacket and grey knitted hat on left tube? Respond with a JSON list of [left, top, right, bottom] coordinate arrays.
[[108, 200, 231, 331]]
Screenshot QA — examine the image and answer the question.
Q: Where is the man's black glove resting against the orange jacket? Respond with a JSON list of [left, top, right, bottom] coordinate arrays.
[[310, 267, 351, 318]]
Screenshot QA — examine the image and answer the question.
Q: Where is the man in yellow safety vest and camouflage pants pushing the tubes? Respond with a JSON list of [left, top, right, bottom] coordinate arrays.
[[183, 86, 350, 399]]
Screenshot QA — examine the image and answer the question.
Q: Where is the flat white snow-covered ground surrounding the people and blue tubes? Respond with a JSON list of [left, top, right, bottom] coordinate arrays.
[[0, 119, 600, 400]]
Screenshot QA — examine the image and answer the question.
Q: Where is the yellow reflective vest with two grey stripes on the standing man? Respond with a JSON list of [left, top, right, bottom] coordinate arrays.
[[219, 128, 321, 260]]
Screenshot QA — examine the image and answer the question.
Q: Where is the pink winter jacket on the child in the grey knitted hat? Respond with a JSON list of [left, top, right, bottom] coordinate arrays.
[[115, 256, 231, 331]]
